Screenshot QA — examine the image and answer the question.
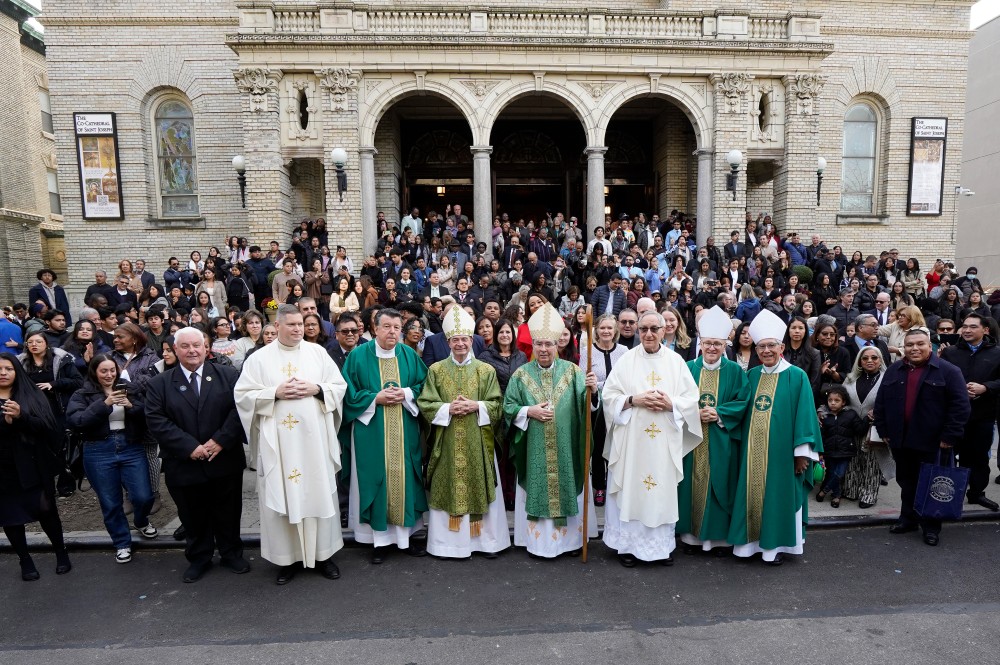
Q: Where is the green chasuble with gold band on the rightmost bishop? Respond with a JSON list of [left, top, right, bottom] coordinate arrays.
[[729, 365, 823, 550]]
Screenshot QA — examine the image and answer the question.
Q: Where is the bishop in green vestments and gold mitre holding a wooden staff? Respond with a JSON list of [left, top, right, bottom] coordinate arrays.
[[503, 303, 597, 558]]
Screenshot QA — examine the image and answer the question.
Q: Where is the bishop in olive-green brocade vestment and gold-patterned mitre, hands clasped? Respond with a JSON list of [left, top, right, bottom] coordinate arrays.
[[417, 305, 510, 558]]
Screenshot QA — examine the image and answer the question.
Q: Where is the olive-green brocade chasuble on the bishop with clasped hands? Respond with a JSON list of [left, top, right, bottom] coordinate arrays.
[[417, 356, 503, 522]]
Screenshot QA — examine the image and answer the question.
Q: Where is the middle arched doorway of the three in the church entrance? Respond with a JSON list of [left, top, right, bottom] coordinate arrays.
[[490, 95, 587, 221]]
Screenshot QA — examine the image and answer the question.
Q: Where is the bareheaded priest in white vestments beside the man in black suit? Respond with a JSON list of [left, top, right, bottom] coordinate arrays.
[[236, 305, 347, 584]]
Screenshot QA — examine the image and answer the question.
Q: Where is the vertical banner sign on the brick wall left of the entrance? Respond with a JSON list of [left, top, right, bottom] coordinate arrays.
[[73, 113, 125, 219]]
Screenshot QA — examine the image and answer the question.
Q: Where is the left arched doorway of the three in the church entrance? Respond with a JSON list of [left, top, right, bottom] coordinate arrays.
[[374, 93, 472, 231]]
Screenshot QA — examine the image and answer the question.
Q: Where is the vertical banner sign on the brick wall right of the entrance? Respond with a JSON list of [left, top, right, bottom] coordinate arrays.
[[906, 118, 948, 215]]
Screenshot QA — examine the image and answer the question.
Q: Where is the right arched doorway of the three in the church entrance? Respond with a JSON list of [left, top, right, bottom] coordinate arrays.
[[604, 95, 698, 227]]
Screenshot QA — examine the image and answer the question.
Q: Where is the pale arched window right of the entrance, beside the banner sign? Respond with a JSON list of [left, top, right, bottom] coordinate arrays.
[[840, 102, 878, 213]]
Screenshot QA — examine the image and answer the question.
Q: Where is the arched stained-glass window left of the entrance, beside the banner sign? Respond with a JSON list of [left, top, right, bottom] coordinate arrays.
[[153, 97, 199, 217]]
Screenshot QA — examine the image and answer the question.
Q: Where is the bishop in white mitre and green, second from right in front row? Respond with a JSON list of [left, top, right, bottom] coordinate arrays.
[[677, 307, 750, 553]]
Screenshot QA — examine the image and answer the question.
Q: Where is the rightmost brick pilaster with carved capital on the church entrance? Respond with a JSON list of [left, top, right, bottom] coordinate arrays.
[[774, 74, 832, 234]]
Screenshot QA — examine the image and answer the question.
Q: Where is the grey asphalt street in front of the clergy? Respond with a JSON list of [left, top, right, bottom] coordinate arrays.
[[0, 522, 1000, 665]]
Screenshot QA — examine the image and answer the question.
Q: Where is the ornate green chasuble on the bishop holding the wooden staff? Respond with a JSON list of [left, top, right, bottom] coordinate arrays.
[[503, 358, 590, 524]]
